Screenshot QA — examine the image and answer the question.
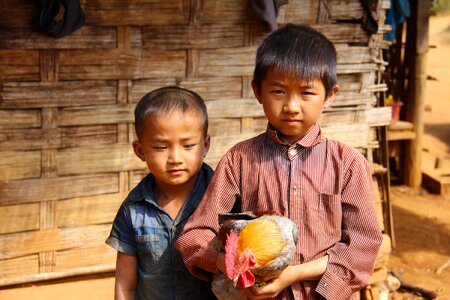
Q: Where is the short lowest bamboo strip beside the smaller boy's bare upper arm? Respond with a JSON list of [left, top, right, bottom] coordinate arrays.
[[54, 246, 117, 272]]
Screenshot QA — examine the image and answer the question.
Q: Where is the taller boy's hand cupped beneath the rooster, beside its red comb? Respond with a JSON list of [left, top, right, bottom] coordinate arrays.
[[242, 266, 297, 299]]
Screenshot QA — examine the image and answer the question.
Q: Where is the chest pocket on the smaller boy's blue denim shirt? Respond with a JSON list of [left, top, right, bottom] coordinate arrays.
[[136, 229, 169, 272]]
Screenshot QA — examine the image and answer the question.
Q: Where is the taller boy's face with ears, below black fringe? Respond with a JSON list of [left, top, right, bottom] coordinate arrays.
[[252, 69, 339, 144]]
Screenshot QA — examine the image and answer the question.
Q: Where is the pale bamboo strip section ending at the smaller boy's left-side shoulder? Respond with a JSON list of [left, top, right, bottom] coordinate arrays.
[[56, 193, 126, 228]]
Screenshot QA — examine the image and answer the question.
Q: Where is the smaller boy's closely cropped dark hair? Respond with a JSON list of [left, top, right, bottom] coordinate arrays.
[[134, 86, 208, 138]]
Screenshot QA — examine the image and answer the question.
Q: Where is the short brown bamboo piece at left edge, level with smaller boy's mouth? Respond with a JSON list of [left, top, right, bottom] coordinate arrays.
[[0, 151, 41, 180]]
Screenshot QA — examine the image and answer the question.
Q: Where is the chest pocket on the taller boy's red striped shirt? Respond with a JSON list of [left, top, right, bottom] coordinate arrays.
[[318, 193, 342, 237]]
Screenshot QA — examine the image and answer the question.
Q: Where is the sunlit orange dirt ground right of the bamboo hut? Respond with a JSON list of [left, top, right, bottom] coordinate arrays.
[[389, 14, 450, 300]]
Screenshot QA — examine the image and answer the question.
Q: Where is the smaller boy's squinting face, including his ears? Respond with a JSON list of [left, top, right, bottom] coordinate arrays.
[[133, 111, 210, 188]]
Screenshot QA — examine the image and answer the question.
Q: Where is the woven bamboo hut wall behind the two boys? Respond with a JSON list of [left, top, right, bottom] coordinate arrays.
[[0, 0, 390, 285]]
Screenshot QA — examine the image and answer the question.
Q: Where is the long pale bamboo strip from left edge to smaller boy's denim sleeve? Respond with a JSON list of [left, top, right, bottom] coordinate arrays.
[[0, 224, 111, 260]]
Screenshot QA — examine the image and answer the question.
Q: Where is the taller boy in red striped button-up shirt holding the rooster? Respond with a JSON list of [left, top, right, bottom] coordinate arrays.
[[176, 24, 382, 300]]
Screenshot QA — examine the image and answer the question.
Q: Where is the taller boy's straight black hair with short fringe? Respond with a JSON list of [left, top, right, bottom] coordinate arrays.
[[253, 24, 337, 96]]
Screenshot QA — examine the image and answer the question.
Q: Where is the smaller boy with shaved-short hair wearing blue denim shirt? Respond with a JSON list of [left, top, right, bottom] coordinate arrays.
[[106, 87, 214, 300]]
